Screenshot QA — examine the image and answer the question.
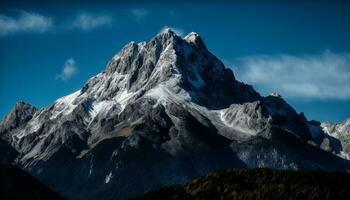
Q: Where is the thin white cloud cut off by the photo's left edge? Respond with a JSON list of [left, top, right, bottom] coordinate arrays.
[[0, 11, 53, 36]]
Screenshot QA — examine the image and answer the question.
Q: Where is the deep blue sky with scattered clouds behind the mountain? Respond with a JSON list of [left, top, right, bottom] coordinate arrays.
[[0, 1, 350, 122]]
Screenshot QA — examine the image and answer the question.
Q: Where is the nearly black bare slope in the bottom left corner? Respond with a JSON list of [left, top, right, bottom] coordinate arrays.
[[0, 164, 63, 200]]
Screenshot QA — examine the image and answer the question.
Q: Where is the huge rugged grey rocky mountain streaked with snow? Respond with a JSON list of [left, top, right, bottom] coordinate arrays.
[[0, 29, 350, 199]]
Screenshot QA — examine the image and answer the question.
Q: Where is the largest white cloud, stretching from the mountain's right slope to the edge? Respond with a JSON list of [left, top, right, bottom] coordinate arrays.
[[232, 51, 350, 100]]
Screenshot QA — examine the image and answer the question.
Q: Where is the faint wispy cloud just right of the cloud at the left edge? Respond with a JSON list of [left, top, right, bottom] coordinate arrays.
[[72, 12, 113, 31]]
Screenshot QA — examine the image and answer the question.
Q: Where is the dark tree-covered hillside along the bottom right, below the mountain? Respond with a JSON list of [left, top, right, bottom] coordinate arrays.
[[134, 169, 350, 200]]
